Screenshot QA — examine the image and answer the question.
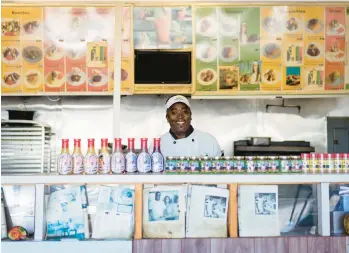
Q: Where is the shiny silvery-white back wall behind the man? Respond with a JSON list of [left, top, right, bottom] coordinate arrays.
[[2, 95, 349, 154]]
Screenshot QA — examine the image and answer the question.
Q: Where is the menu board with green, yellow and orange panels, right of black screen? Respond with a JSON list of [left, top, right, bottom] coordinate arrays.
[[194, 6, 349, 95]]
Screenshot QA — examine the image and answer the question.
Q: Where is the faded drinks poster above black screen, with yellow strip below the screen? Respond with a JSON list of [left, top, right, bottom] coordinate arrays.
[[133, 6, 193, 94]]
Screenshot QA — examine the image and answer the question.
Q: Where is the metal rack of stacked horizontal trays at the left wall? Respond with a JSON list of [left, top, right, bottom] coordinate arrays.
[[1, 120, 53, 174]]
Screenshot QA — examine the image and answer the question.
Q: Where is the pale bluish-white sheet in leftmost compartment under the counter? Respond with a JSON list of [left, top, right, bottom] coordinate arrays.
[[3, 185, 35, 236]]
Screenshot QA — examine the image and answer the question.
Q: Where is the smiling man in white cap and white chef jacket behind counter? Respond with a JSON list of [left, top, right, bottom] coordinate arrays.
[[161, 95, 221, 157]]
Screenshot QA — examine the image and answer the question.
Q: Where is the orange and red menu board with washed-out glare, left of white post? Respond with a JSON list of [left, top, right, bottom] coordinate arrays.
[[1, 7, 121, 94]]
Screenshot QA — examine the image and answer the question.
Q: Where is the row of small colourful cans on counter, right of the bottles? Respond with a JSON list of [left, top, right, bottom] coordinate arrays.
[[165, 153, 349, 173]]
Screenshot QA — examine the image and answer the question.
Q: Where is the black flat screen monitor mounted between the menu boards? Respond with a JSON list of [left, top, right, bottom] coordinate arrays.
[[135, 50, 192, 84]]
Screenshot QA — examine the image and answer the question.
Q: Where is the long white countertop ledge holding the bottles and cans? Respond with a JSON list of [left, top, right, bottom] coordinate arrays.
[[1, 173, 349, 185]]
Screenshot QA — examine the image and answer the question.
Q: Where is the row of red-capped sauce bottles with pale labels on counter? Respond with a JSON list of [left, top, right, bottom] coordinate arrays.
[[57, 138, 164, 175]]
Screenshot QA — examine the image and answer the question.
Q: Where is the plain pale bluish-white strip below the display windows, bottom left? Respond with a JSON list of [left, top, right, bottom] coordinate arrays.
[[1, 240, 132, 253]]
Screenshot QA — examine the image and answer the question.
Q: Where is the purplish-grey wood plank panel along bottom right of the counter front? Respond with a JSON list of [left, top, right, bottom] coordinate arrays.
[[133, 237, 346, 253]]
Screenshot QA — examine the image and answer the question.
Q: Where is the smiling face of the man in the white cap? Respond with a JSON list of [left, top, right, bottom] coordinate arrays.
[[166, 103, 191, 138]]
